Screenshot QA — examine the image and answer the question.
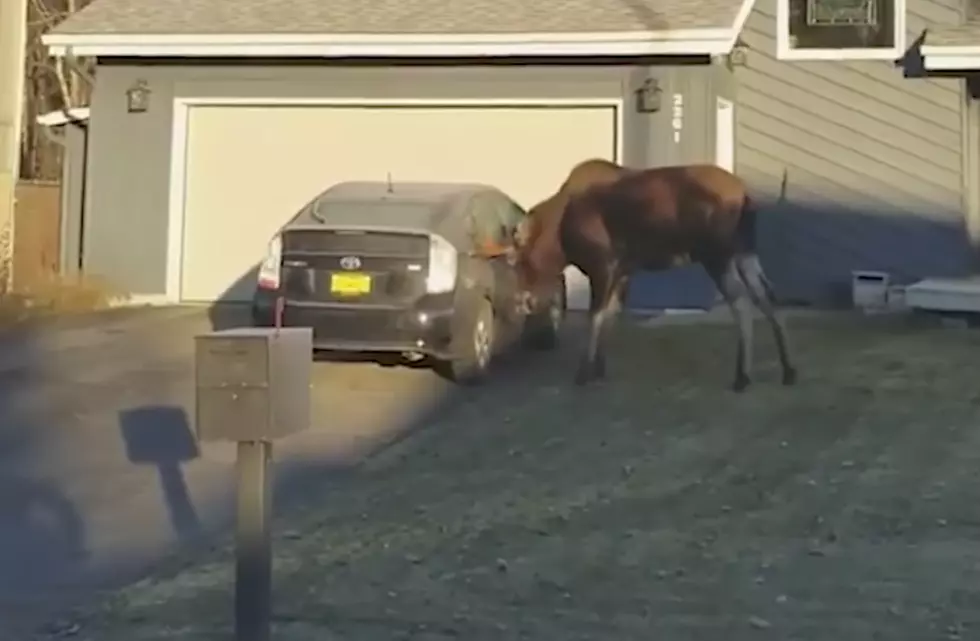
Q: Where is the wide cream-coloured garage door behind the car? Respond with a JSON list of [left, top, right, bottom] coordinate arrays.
[[181, 106, 616, 307]]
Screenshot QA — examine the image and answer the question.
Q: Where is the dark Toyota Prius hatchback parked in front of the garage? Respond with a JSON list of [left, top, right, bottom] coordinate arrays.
[[252, 182, 565, 382]]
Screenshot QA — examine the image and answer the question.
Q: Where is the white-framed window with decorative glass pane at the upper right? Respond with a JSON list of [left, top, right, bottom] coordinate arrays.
[[776, 0, 905, 60]]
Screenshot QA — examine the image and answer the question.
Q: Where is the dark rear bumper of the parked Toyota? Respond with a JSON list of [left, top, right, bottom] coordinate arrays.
[[252, 294, 453, 359]]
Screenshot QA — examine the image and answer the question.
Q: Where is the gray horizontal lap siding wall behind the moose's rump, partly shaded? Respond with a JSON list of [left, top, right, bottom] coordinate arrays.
[[735, 0, 972, 303]]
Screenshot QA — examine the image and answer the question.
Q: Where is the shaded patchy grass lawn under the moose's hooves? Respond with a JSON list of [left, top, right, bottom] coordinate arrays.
[[53, 319, 980, 641]]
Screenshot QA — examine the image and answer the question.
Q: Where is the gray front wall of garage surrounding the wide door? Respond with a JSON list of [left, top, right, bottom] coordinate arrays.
[[83, 64, 711, 296]]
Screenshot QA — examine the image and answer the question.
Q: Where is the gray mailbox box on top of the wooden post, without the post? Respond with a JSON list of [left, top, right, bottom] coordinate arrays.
[[195, 327, 313, 441]]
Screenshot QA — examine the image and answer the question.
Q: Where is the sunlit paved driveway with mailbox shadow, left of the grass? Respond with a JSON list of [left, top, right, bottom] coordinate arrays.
[[0, 308, 464, 638]]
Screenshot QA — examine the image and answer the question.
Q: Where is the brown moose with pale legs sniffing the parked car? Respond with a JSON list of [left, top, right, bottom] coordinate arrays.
[[511, 159, 797, 392]]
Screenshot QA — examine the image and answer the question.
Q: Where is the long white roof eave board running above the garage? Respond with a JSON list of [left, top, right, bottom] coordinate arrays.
[[42, 28, 741, 58]]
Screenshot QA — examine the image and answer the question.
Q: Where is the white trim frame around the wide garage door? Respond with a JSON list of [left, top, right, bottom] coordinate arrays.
[[166, 96, 624, 303]]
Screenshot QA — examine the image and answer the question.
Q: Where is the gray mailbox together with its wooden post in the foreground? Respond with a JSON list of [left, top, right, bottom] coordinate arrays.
[[195, 327, 313, 641]]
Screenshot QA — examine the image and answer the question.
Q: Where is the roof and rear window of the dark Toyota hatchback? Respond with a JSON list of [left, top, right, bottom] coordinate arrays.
[[286, 181, 510, 246]]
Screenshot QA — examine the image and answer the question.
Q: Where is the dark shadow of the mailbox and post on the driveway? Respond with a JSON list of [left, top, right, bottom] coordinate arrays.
[[119, 405, 202, 540]]
